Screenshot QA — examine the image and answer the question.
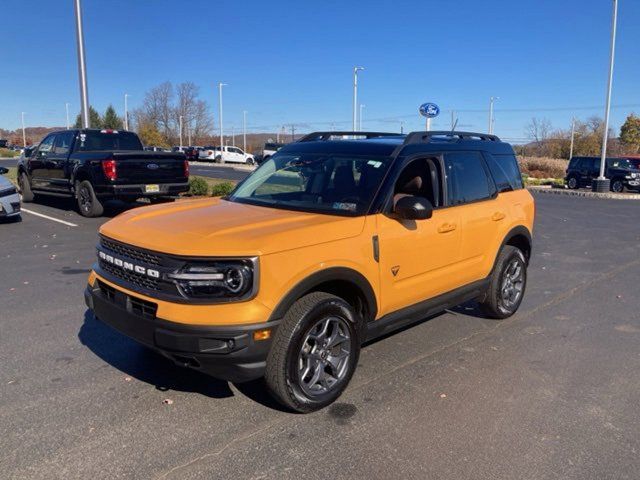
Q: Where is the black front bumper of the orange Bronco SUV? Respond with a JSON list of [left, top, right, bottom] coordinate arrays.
[[84, 279, 280, 383]]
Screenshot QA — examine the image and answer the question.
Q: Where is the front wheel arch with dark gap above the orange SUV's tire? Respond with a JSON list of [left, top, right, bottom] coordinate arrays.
[[269, 267, 378, 326]]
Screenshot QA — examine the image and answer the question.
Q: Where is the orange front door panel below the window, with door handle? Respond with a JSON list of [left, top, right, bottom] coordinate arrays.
[[376, 208, 461, 315]]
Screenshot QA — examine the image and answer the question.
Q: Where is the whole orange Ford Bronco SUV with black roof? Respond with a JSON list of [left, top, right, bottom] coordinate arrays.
[[85, 132, 534, 412]]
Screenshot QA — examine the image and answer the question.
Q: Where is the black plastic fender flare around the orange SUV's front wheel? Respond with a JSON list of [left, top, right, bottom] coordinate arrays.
[[269, 267, 378, 324]]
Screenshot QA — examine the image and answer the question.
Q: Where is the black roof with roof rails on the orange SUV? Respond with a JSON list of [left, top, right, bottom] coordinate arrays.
[[279, 131, 513, 156]]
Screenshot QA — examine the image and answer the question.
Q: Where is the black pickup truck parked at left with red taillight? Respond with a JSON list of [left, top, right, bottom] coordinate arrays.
[[18, 129, 189, 217]]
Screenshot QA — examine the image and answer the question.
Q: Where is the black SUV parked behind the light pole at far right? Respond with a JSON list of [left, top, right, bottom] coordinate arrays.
[[565, 157, 640, 193]]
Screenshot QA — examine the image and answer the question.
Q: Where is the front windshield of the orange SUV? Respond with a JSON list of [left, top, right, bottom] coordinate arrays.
[[229, 153, 390, 215]]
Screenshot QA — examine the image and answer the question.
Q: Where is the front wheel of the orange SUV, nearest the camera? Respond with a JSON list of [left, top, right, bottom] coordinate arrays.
[[265, 292, 360, 413]]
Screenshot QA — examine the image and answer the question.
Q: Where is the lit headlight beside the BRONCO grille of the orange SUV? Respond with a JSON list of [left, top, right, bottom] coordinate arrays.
[[169, 258, 258, 301]]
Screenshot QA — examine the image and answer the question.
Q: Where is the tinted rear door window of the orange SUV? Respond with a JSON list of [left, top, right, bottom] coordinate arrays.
[[444, 152, 495, 206]]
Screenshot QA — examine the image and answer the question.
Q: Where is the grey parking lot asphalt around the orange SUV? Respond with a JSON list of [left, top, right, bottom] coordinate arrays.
[[0, 195, 640, 480]]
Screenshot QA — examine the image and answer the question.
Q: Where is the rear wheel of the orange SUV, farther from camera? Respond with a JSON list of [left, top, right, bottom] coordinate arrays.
[[481, 245, 527, 319]]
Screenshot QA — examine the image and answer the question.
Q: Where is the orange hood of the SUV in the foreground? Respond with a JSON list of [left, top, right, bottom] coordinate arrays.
[[100, 198, 365, 257]]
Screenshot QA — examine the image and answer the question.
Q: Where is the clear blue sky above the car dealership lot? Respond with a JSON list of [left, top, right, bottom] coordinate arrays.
[[0, 0, 640, 141]]
